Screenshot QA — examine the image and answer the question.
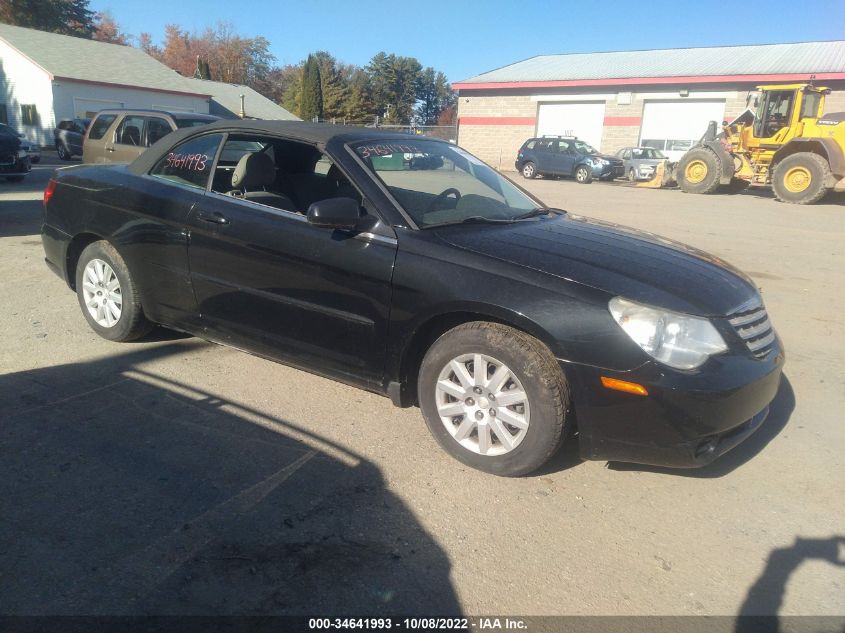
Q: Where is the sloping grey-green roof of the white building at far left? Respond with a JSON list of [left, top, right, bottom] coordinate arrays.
[[0, 24, 209, 96]]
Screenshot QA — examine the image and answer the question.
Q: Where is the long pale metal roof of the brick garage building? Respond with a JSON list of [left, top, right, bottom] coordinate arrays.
[[455, 40, 845, 88]]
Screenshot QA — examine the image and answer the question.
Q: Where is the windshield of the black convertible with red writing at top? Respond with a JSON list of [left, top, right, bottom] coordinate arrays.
[[352, 139, 542, 228]]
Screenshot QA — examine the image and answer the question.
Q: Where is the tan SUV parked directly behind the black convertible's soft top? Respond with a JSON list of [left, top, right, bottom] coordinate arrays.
[[82, 110, 220, 163]]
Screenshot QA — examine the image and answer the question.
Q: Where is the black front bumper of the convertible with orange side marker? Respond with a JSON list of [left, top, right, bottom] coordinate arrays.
[[561, 341, 784, 468]]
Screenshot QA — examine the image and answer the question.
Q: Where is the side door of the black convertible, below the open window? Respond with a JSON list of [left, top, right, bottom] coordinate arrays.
[[188, 137, 396, 387]]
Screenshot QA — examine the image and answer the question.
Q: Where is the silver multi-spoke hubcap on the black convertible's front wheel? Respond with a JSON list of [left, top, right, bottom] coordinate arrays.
[[435, 354, 530, 457]]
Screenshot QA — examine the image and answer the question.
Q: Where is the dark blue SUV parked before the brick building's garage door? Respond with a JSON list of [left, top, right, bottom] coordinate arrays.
[[514, 136, 625, 184]]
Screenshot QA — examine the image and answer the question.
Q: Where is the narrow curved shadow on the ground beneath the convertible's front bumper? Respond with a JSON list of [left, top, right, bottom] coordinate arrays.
[[608, 375, 795, 479]]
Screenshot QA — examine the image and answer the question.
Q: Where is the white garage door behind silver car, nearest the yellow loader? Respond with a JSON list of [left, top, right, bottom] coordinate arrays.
[[640, 100, 725, 160]]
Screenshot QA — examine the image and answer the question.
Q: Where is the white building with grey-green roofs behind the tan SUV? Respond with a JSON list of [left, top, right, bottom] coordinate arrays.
[[0, 24, 297, 146]]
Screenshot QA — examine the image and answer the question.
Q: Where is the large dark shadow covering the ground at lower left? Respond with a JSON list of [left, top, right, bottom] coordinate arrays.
[[0, 339, 460, 616]]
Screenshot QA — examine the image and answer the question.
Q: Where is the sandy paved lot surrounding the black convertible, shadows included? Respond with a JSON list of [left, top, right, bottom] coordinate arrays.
[[0, 159, 845, 615]]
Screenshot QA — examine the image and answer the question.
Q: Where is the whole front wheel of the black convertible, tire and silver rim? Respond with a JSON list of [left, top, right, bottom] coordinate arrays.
[[417, 321, 570, 477]]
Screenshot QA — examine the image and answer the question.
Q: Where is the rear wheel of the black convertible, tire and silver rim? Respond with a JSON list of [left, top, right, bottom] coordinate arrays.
[[76, 240, 153, 342]]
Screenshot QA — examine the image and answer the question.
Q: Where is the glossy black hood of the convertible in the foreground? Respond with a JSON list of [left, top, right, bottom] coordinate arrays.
[[437, 215, 757, 316]]
